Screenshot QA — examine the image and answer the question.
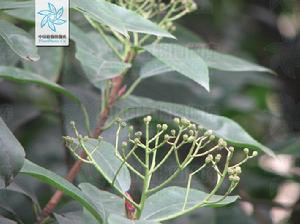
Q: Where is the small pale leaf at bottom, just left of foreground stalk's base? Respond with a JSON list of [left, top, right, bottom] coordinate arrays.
[[79, 183, 126, 220]]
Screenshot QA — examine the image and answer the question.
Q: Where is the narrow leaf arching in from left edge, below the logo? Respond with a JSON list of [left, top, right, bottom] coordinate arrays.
[[0, 66, 79, 102]]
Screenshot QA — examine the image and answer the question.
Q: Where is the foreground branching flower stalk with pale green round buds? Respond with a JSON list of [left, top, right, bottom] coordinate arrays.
[[65, 116, 257, 219]]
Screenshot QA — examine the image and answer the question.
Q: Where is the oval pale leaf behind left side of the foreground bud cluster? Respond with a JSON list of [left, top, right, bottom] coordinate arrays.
[[67, 138, 131, 193]]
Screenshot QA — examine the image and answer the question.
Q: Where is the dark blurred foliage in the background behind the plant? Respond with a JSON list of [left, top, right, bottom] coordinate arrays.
[[0, 0, 300, 224]]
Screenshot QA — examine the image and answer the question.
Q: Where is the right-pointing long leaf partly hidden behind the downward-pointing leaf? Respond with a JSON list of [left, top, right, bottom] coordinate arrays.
[[141, 48, 274, 78]]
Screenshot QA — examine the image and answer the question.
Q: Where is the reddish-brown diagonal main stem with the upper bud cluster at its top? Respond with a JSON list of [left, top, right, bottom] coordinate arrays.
[[37, 0, 197, 220]]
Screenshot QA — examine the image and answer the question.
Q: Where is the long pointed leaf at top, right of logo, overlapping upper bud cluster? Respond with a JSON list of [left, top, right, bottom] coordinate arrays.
[[71, 0, 174, 38]]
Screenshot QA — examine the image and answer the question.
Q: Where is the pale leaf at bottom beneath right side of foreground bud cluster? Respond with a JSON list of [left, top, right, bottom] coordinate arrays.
[[141, 187, 239, 221]]
